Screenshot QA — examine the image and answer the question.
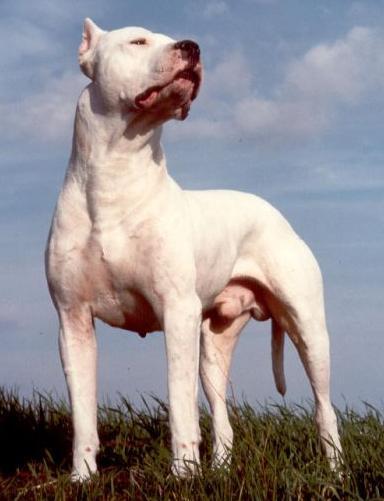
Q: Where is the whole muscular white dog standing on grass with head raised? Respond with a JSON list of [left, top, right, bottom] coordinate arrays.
[[46, 19, 340, 480]]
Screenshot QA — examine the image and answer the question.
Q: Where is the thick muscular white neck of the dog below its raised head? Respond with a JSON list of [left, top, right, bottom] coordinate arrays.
[[67, 84, 167, 222]]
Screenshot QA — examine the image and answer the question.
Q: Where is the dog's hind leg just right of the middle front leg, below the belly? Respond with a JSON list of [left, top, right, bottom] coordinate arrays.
[[200, 311, 250, 466]]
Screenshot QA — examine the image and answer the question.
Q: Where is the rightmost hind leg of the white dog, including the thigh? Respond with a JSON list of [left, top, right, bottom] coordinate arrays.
[[255, 234, 341, 469]]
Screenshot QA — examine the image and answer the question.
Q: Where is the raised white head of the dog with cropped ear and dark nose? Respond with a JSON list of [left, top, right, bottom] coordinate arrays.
[[79, 19, 202, 122]]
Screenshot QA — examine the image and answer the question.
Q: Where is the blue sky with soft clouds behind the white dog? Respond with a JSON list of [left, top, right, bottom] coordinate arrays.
[[0, 0, 384, 409]]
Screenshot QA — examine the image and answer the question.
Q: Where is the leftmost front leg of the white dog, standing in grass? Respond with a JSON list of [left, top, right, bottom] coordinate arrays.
[[59, 307, 99, 481]]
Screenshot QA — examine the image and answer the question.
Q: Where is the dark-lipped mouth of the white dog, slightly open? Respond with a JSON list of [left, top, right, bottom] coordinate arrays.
[[135, 64, 201, 114]]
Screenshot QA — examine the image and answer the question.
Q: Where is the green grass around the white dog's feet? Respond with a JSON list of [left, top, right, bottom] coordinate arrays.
[[0, 388, 384, 501]]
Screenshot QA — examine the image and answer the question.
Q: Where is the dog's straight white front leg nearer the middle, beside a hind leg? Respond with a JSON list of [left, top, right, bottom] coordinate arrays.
[[164, 296, 201, 476]]
